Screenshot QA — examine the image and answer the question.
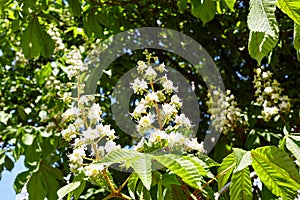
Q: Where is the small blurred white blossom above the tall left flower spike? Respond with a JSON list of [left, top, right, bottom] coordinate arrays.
[[66, 46, 87, 79]]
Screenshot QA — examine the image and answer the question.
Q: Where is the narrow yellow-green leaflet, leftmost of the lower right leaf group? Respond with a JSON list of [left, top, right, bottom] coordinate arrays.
[[218, 153, 236, 191]]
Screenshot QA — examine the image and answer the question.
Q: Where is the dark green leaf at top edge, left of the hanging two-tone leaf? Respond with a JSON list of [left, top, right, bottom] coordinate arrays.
[[191, 0, 217, 24]]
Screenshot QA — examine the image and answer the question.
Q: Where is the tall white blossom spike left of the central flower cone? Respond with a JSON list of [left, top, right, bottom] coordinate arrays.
[[61, 58, 121, 178]]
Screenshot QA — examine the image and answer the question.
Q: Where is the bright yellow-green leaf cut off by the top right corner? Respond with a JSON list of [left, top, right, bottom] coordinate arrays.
[[277, 0, 300, 25]]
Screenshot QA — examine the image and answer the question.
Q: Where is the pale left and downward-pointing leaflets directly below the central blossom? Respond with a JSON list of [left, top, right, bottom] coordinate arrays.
[[98, 149, 152, 190]]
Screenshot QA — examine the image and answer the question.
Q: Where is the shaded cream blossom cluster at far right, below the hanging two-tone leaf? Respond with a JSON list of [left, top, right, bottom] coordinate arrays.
[[253, 68, 291, 121]]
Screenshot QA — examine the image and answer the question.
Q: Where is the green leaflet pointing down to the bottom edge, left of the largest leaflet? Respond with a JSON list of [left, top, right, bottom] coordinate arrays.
[[229, 167, 253, 200]]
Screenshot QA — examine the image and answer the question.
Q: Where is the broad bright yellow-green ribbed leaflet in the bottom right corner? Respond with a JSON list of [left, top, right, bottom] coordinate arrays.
[[251, 146, 300, 199]]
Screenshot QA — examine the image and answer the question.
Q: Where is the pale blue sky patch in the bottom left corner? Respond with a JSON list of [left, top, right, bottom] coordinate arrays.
[[0, 157, 26, 200]]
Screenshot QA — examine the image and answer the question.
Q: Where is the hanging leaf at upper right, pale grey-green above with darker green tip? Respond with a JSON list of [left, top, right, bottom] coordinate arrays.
[[247, 0, 278, 63]]
